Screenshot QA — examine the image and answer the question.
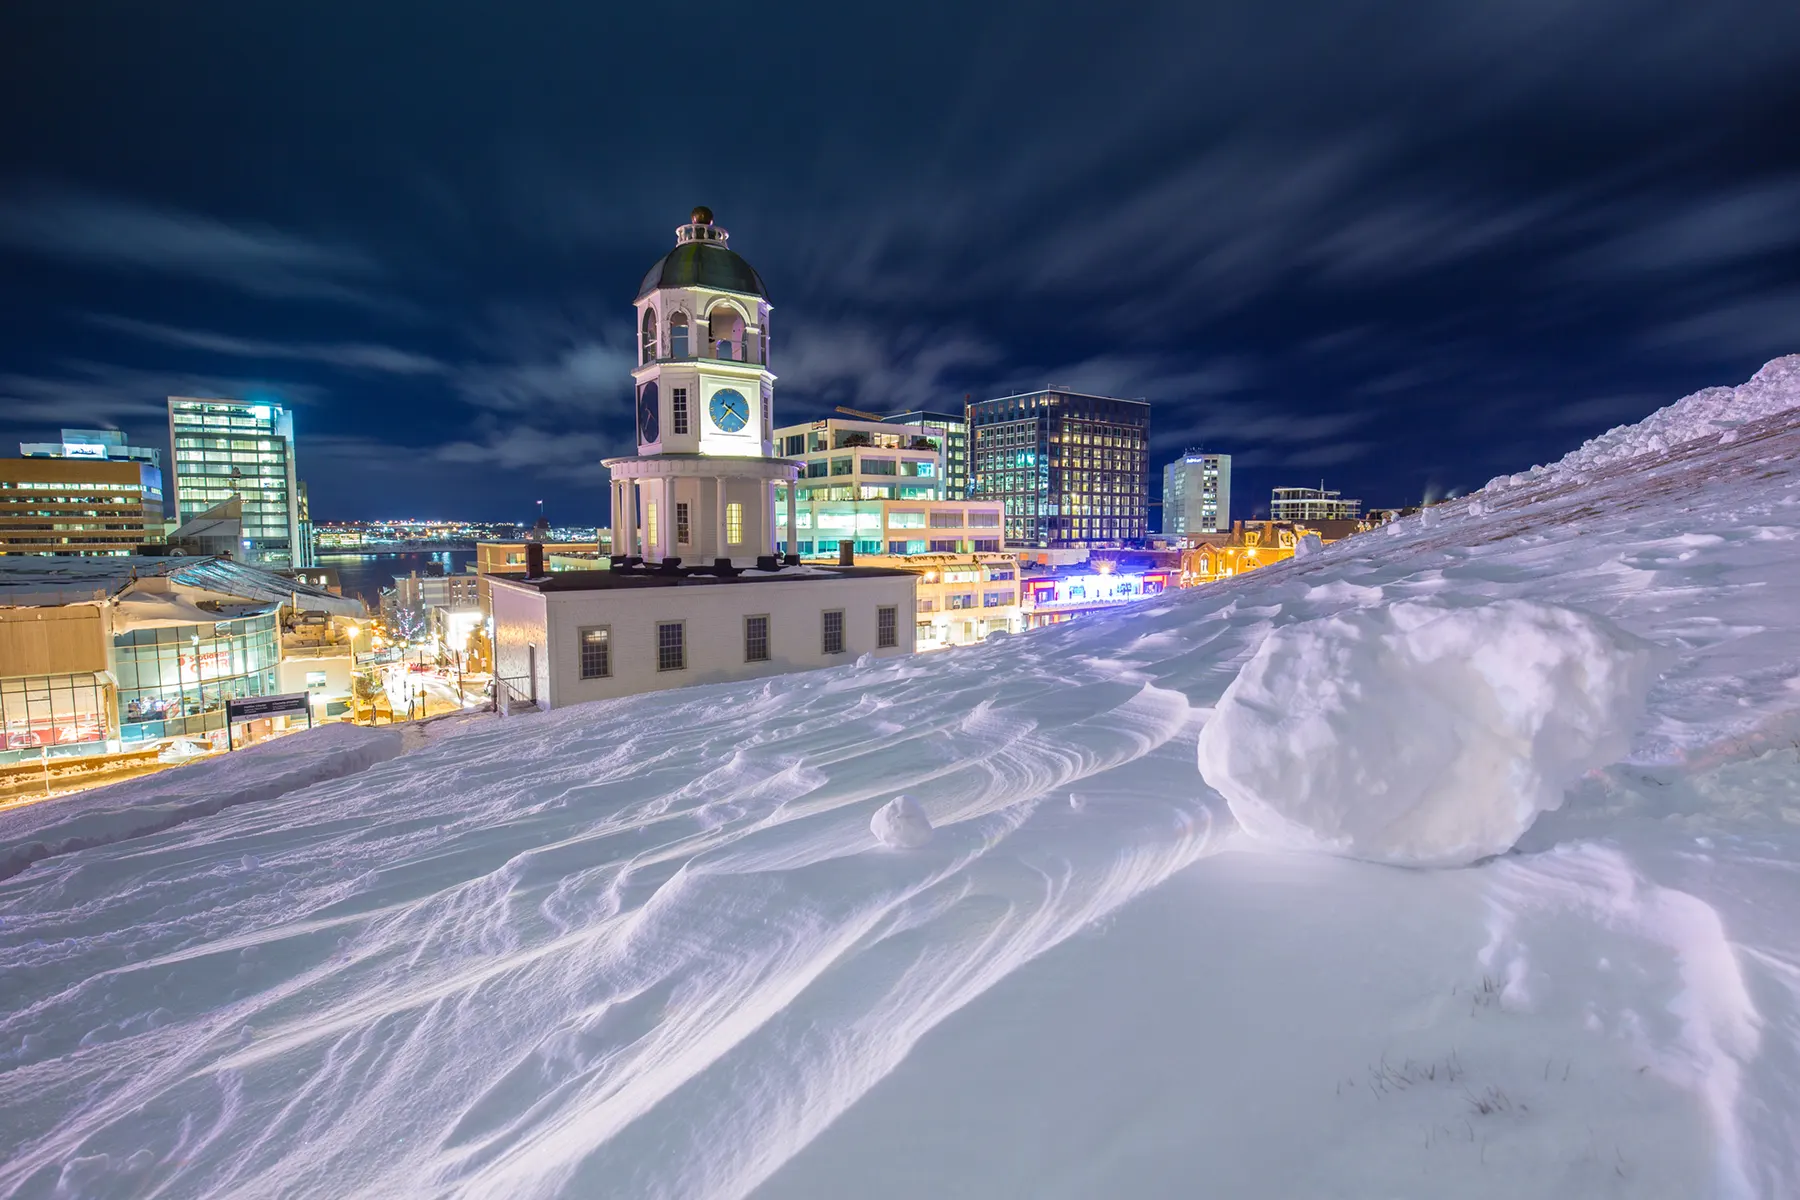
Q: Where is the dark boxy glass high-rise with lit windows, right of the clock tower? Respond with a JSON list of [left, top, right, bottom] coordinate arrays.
[[968, 389, 1150, 547]]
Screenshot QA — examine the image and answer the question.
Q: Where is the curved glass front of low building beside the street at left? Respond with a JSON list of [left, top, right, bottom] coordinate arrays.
[[113, 612, 281, 741]]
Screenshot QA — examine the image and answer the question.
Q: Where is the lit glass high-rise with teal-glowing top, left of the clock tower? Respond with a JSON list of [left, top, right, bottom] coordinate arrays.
[[169, 396, 310, 569]]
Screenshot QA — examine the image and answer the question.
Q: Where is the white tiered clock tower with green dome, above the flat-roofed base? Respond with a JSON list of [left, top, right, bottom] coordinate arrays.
[[605, 207, 797, 567]]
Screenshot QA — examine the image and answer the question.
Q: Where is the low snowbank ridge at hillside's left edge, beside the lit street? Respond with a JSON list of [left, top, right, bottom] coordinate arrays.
[[0, 725, 405, 880]]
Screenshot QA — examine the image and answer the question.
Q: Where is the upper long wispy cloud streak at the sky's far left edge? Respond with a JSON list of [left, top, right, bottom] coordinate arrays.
[[0, 187, 391, 306]]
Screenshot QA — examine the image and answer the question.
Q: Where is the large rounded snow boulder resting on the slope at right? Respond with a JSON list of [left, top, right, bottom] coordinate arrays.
[[1199, 601, 1654, 867]]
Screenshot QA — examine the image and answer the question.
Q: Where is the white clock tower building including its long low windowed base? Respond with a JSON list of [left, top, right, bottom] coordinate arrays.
[[488, 209, 918, 709]]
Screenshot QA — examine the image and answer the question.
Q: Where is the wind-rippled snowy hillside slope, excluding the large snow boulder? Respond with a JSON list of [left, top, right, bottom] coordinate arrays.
[[0, 360, 1800, 1200]]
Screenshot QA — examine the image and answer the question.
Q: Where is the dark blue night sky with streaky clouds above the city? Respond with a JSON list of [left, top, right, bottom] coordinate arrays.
[[0, 0, 1800, 522]]
